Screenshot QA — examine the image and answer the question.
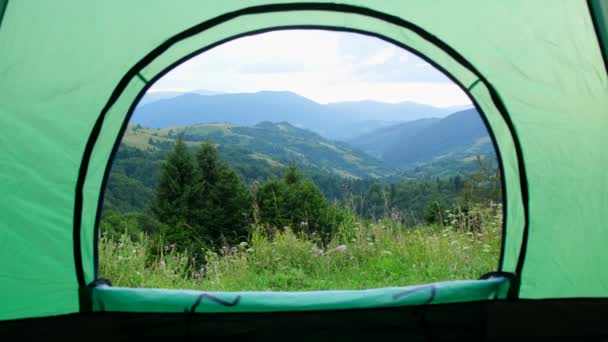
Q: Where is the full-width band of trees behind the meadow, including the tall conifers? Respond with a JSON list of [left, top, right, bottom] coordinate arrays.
[[101, 139, 502, 260]]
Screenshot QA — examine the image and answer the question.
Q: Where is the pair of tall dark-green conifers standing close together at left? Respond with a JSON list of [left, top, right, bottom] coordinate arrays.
[[150, 139, 252, 254]]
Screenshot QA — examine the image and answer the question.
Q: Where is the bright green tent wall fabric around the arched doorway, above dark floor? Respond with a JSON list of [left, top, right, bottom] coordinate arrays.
[[0, 0, 608, 330]]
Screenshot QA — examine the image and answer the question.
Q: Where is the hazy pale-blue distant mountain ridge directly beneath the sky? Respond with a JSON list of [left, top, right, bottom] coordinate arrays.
[[131, 91, 468, 140]]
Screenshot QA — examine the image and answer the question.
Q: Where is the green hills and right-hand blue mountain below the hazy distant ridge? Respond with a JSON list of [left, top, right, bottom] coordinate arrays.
[[104, 108, 496, 211]]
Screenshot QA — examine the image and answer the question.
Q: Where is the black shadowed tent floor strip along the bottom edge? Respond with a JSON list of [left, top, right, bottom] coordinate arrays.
[[0, 299, 608, 341]]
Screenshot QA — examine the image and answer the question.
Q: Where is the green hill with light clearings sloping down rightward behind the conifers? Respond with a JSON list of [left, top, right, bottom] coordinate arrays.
[[105, 122, 393, 211]]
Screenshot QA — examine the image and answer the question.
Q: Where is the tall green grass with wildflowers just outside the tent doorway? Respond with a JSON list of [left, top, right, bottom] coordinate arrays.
[[99, 206, 502, 291]]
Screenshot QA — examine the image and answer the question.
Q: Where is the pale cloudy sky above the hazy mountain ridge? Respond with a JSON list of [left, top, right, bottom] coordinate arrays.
[[149, 30, 471, 107]]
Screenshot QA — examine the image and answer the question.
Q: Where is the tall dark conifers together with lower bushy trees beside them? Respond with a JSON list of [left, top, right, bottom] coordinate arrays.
[[102, 139, 342, 256]]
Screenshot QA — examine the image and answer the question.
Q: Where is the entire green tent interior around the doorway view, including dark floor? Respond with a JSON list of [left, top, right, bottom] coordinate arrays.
[[0, 0, 608, 340]]
